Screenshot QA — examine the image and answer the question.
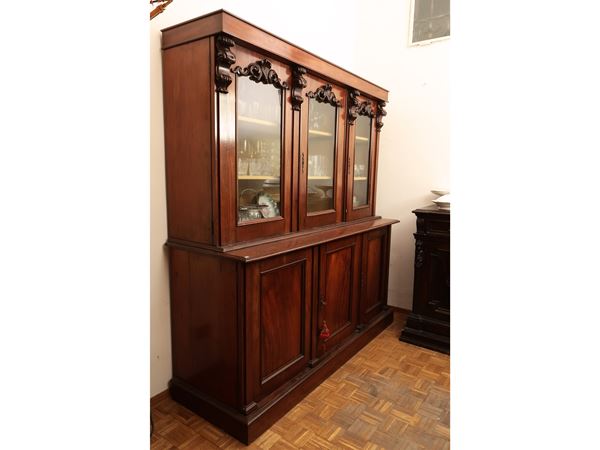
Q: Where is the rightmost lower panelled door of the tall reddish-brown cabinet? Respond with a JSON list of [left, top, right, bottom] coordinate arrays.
[[360, 227, 389, 324]]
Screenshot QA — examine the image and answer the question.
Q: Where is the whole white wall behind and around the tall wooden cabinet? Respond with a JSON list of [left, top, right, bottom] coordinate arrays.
[[150, 0, 450, 395]]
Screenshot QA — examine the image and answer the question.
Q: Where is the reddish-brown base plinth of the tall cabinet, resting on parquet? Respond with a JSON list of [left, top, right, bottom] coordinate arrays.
[[169, 309, 393, 444]]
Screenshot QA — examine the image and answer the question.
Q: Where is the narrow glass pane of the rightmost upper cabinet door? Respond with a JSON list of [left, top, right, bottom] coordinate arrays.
[[352, 116, 371, 207]]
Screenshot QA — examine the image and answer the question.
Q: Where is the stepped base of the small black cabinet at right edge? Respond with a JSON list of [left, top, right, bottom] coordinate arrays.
[[400, 313, 450, 355]]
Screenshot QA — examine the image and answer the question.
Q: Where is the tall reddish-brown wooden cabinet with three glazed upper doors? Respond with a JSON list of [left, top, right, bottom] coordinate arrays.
[[162, 10, 397, 443]]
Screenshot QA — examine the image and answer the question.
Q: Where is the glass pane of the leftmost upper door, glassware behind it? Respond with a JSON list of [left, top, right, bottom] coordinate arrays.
[[236, 77, 282, 222]]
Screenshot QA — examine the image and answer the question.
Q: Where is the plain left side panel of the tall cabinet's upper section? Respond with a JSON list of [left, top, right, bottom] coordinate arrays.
[[162, 39, 216, 244]]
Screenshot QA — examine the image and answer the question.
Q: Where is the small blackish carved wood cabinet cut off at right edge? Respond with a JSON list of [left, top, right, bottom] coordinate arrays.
[[400, 206, 450, 354]]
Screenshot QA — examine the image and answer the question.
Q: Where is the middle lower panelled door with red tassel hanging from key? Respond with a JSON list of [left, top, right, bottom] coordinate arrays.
[[314, 236, 360, 358]]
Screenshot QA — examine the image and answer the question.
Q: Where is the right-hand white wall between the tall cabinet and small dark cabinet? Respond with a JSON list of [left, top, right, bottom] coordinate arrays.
[[347, 0, 450, 309]]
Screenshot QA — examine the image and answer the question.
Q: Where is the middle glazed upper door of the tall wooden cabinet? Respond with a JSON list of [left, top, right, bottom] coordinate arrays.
[[298, 75, 346, 229]]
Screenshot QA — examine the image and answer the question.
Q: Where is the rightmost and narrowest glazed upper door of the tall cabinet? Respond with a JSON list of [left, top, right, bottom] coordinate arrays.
[[346, 95, 378, 220]]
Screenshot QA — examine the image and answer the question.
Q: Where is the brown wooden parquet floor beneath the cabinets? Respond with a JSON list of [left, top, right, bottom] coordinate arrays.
[[151, 312, 450, 450]]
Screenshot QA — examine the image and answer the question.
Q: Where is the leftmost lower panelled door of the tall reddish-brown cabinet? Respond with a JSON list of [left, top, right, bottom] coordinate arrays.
[[246, 249, 312, 407]]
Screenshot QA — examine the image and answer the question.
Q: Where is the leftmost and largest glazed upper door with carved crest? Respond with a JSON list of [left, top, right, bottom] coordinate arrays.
[[217, 46, 292, 245]]
